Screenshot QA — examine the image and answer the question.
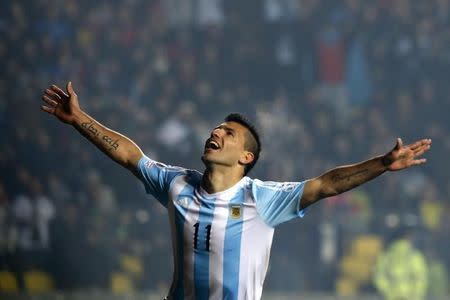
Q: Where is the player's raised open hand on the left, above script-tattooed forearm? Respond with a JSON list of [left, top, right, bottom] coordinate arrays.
[[41, 82, 80, 124]]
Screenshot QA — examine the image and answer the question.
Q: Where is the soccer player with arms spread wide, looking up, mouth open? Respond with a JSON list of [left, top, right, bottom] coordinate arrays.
[[42, 82, 431, 299]]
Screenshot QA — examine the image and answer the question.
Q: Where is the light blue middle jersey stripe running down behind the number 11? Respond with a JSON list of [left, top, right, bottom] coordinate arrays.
[[194, 198, 215, 300]]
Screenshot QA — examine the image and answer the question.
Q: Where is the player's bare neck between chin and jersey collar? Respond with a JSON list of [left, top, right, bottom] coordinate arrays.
[[202, 167, 243, 194]]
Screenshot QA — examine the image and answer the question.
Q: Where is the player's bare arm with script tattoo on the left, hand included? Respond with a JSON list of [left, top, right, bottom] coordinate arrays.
[[41, 82, 143, 174]]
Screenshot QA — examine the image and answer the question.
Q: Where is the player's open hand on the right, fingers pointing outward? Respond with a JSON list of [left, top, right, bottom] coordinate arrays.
[[383, 138, 431, 171]]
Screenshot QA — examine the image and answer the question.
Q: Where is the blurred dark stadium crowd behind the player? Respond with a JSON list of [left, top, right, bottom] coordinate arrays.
[[0, 0, 450, 291]]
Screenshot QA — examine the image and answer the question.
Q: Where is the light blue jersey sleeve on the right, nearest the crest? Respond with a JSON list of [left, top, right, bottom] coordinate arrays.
[[252, 179, 306, 227]]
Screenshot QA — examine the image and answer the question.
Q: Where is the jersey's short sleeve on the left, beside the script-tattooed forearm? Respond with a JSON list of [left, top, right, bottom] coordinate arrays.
[[137, 155, 186, 207]]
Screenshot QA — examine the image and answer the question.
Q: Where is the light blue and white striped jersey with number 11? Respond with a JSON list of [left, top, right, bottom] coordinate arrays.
[[138, 156, 305, 300]]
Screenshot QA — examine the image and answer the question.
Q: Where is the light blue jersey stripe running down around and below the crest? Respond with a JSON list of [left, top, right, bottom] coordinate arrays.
[[223, 189, 245, 300]]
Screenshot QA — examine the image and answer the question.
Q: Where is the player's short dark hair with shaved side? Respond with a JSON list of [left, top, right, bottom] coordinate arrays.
[[224, 113, 261, 175]]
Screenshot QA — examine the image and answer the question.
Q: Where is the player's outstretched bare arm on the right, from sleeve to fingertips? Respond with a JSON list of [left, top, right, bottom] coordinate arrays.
[[301, 138, 431, 209]]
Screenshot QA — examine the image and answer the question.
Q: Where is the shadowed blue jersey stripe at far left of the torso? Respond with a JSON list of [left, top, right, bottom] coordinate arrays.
[[171, 175, 195, 300]]
